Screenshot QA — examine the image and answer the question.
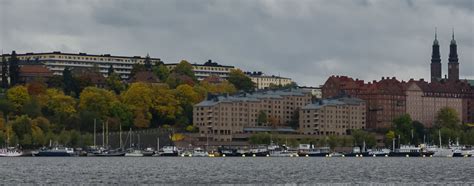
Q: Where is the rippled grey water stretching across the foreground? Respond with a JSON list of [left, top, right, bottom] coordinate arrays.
[[0, 157, 474, 185]]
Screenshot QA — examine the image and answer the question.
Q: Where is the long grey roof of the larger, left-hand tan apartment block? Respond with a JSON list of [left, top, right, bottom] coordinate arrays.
[[196, 89, 310, 106]]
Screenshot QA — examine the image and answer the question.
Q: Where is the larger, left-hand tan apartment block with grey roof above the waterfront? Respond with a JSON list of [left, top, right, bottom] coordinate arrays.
[[193, 89, 311, 141]]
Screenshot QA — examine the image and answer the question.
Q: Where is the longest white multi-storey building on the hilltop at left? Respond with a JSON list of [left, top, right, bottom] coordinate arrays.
[[0, 52, 161, 79]]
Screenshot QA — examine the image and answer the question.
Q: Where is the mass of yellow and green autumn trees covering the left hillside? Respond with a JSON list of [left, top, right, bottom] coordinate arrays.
[[0, 51, 255, 147]]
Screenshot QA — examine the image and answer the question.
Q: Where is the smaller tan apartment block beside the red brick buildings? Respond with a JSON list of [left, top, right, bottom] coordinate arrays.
[[299, 97, 366, 136]]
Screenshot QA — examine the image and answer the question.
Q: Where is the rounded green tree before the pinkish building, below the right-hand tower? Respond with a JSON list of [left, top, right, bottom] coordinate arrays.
[[435, 107, 461, 129]]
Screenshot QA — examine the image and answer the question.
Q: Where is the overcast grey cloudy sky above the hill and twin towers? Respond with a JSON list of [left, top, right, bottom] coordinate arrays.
[[0, 0, 474, 86]]
